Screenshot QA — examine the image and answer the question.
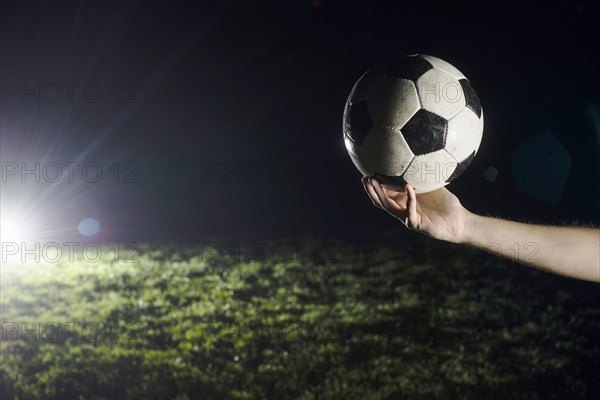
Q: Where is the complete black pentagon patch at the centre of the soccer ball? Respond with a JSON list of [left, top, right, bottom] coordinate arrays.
[[401, 109, 448, 156]]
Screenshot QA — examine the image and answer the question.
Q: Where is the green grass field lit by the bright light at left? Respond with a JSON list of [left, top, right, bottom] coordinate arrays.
[[0, 232, 600, 400]]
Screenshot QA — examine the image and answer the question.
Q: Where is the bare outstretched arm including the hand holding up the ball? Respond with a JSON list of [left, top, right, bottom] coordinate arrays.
[[363, 178, 600, 282]]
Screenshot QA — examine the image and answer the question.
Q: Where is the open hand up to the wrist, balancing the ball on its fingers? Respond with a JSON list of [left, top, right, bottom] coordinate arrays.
[[362, 176, 471, 243]]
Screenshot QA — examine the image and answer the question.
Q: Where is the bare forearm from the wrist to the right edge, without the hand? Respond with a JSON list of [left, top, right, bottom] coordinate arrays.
[[459, 213, 600, 282]]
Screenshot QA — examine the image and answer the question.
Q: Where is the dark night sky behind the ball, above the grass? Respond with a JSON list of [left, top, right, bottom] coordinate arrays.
[[0, 0, 600, 240]]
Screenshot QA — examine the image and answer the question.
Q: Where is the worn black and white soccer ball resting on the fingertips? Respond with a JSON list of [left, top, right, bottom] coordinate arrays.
[[343, 54, 483, 193]]
